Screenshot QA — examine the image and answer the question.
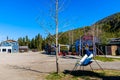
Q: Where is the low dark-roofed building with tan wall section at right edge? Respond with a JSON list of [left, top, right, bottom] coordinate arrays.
[[97, 38, 120, 56]]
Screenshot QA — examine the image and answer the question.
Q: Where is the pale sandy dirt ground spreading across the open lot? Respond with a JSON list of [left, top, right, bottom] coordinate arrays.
[[0, 52, 120, 80]]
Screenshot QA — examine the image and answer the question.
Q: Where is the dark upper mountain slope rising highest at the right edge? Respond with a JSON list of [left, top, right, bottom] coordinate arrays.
[[96, 12, 120, 32]]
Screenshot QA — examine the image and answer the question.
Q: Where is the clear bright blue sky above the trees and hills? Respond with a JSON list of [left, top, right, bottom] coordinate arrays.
[[0, 0, 120, 41]]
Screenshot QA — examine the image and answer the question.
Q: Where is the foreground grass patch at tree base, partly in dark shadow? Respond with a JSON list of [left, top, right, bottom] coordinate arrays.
[[46, 70, 120, 80]]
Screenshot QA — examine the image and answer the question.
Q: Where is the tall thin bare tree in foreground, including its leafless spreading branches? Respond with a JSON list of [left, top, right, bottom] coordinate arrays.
[[36, 0, 68, 73]]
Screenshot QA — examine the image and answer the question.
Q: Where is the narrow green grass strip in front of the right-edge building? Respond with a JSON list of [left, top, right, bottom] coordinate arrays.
[[94, 56, 120, 62]]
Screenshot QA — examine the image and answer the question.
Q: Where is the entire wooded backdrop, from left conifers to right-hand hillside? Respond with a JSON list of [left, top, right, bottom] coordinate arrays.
[[18, 13, 120, 50]]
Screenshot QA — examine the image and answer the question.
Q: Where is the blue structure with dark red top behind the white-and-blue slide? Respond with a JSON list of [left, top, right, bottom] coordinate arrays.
[[75, 34, 100, 53]]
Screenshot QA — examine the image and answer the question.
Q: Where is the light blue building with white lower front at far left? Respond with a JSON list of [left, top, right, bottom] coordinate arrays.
[[0, 40, 19, 53]]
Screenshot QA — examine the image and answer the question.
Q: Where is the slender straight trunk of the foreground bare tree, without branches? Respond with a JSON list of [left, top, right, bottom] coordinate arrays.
[[55, 0, 59, 73]]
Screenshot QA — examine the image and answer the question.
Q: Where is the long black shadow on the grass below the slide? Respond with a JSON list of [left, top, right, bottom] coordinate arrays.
[[64, 70, 120, 80]]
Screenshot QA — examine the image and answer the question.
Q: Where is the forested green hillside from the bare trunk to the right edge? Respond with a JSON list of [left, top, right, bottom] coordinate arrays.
[[55, 13, 120, 44]]
